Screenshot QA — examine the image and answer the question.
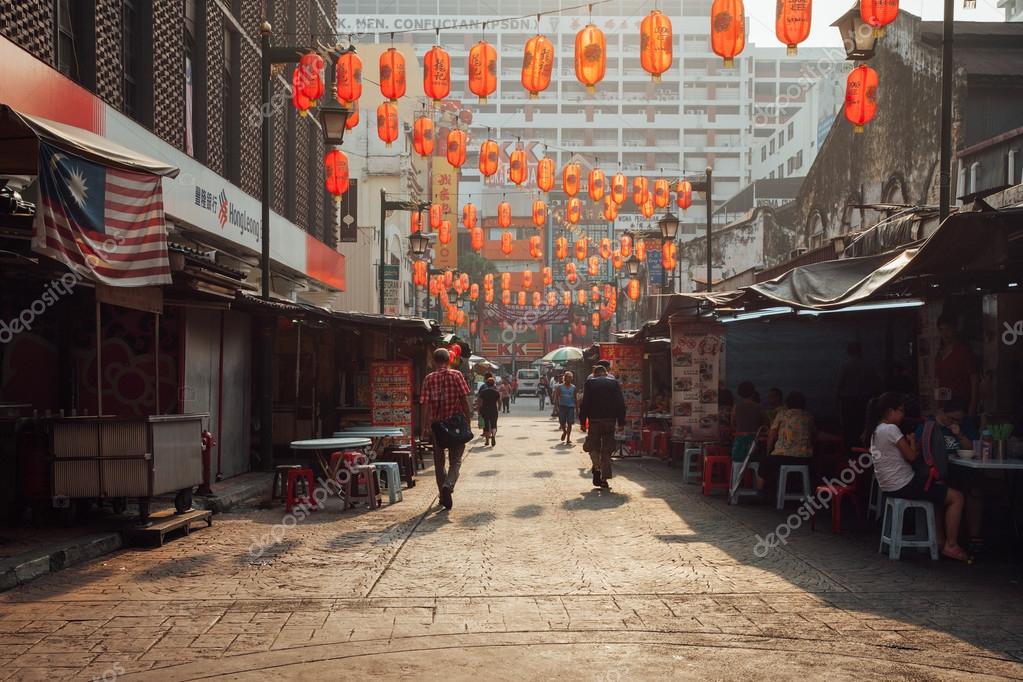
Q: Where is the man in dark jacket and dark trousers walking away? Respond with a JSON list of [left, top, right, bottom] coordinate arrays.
[[579, 365, 625, 488]]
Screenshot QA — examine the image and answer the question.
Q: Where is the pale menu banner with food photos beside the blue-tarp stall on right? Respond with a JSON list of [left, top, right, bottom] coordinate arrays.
[[671, 319, 724, 442]]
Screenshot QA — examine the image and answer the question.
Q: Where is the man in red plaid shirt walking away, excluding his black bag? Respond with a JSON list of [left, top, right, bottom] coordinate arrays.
[[419, 348, 472, 509]]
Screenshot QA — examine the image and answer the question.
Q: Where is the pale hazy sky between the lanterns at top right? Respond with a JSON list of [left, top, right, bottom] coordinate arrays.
[[746, 0, 1006, 46]]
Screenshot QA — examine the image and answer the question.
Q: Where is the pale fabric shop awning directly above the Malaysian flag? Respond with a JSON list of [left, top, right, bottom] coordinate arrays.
[[0, 104, 178, 178]]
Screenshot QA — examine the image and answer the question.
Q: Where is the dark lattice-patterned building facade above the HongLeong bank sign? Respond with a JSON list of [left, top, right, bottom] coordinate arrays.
[[0, 0, 338, 245]]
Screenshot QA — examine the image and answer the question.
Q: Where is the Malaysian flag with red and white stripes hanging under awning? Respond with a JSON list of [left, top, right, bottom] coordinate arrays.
[[32, 142, 171, 286]]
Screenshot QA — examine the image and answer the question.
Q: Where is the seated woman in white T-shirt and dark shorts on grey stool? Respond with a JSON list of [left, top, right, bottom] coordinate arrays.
[[863, 393, 970, 561]]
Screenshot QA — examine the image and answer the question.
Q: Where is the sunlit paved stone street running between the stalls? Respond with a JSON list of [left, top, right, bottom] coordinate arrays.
[[0, 400, 1023, 681]]
